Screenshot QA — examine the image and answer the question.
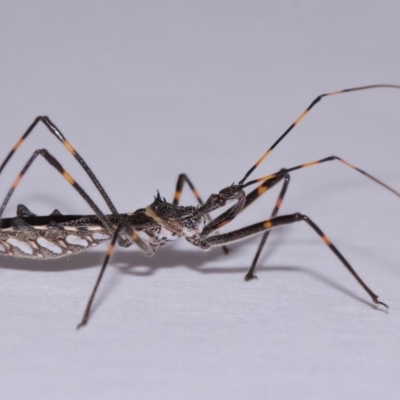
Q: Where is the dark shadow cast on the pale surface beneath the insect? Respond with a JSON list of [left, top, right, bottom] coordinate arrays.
[[0, 241, 382, 313]]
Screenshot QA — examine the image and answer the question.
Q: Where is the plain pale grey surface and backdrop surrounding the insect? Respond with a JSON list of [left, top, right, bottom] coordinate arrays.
[[0, 0, 400, 400]]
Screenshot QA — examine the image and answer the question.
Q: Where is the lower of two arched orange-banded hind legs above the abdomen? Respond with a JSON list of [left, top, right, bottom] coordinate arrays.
[[0, 149, 122, 242]]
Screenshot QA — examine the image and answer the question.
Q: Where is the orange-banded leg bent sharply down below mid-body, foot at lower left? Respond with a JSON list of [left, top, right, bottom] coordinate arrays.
[[76, 222, 149, 329]]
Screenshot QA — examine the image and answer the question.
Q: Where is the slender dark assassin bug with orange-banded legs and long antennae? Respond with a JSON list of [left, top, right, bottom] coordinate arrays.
[[0, 84, 400, 328]]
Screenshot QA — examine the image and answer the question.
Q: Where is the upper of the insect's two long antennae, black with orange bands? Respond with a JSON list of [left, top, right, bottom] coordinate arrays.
[[239, 84, 400, 185]]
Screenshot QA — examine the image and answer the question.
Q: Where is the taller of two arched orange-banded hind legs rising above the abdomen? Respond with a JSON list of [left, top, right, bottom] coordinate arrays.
[[0, 116, 118, 214]]
